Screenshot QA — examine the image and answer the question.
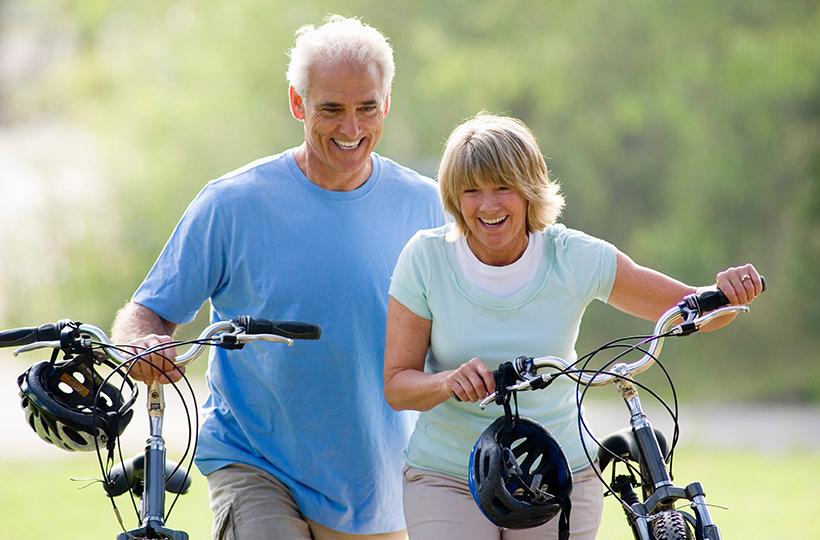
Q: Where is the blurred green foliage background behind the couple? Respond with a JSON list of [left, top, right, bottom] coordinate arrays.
[[0, 0, 820, 402]]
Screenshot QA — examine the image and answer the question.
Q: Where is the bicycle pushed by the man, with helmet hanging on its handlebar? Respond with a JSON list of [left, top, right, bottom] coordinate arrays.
[[0, 316, 321, 540]]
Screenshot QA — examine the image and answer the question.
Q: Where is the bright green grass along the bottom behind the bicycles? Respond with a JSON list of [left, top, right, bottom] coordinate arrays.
[[0, 450, 820, 540]]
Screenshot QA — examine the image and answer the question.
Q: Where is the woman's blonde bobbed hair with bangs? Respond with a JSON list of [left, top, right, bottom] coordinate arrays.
[[438, 111, 564, 240]]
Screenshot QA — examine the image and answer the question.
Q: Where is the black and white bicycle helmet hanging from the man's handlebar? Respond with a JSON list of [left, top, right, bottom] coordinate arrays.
[[17, 353, 137, 451]]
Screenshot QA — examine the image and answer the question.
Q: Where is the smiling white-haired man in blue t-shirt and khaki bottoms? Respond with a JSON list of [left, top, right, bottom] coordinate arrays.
[[112, 16, 444, 540]]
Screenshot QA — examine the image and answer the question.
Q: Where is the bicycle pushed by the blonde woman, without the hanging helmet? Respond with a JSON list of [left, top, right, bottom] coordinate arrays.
[[471, 281, 765, 540]]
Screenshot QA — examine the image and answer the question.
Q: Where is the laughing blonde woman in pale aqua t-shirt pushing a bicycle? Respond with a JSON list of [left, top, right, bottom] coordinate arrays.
[[384, 113, 762, 540]]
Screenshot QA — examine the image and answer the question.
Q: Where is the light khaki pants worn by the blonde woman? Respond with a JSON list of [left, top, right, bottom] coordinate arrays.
[[404, 467, 604, 540]]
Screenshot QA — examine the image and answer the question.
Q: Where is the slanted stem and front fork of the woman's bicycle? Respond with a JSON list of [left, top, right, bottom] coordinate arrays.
[[613, 364, 720, 540]]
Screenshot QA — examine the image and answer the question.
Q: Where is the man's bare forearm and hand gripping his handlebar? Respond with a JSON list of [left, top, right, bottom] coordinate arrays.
[[111, 302, 184, 384]]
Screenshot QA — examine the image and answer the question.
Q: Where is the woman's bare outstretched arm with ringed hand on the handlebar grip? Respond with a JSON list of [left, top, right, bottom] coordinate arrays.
[[608, 251, 763, 330]]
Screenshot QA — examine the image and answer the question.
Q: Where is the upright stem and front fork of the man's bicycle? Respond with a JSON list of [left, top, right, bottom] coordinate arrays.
[[117, 381, 188, 540]]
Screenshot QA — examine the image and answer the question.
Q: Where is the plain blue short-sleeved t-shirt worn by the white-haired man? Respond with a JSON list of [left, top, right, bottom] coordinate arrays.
[[133, 150, 445, 534]]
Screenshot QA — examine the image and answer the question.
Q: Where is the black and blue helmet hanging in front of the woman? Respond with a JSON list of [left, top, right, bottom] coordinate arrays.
[[468, 416, 572, 538]]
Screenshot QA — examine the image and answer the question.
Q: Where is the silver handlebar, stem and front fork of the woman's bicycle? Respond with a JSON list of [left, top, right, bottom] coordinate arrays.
[[479, 293, 749, 540]]
